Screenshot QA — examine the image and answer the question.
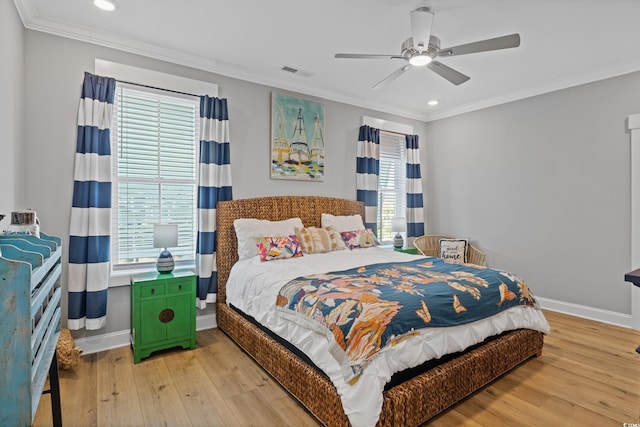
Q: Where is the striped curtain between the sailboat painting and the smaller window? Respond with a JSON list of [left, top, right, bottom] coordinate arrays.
[[356, 125, 380, 235]]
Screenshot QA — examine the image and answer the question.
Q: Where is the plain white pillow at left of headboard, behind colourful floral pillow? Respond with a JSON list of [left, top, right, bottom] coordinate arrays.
[[233, 218, 304, 259]]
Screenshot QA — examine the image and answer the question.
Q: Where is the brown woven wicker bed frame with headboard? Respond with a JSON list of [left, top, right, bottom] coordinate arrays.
[[216, 196, 543, 426]]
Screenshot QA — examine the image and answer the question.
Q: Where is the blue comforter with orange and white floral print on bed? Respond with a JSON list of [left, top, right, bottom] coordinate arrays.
[[276, 258, 538, 383]]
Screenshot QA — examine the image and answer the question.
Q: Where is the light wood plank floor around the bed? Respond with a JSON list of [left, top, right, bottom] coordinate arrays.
[[34, 311, 640, 427]]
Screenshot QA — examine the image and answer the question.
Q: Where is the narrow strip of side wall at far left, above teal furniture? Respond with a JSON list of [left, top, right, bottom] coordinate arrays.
[[0, 1, 26, 224]]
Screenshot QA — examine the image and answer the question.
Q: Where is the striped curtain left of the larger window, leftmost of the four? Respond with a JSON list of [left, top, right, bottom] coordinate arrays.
[[67, 73, 116, 329]]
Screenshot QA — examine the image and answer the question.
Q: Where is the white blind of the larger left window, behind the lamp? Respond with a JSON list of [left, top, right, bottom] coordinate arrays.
[[111, 83, 199, 266]]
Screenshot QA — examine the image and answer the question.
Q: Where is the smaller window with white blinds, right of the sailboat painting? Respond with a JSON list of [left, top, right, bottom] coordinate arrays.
[[377, 131, 407, 244]]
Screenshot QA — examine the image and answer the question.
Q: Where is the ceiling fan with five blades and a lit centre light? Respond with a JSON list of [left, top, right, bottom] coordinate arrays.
[[335, 7, 520, 89]]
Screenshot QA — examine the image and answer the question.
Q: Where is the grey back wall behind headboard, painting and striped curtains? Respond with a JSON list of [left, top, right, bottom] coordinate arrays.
[[25, 30, 426, 337]]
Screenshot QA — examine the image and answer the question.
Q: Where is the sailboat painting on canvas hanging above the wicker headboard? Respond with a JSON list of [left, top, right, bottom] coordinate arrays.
[[271, 92, 324, 181]]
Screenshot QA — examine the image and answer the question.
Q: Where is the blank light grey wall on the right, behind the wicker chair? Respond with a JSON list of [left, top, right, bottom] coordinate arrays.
[[423, 73, 640, 315]]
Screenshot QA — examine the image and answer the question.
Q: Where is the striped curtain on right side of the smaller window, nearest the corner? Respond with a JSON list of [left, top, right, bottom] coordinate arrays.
[[405, 135, 424, 242]]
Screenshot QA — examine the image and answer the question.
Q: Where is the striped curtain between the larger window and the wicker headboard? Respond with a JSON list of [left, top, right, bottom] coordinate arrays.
[[196, 96, 232, 308]]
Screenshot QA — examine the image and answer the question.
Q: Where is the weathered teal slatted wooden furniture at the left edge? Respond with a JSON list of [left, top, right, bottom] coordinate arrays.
[[0, 233, 62, 426]]
